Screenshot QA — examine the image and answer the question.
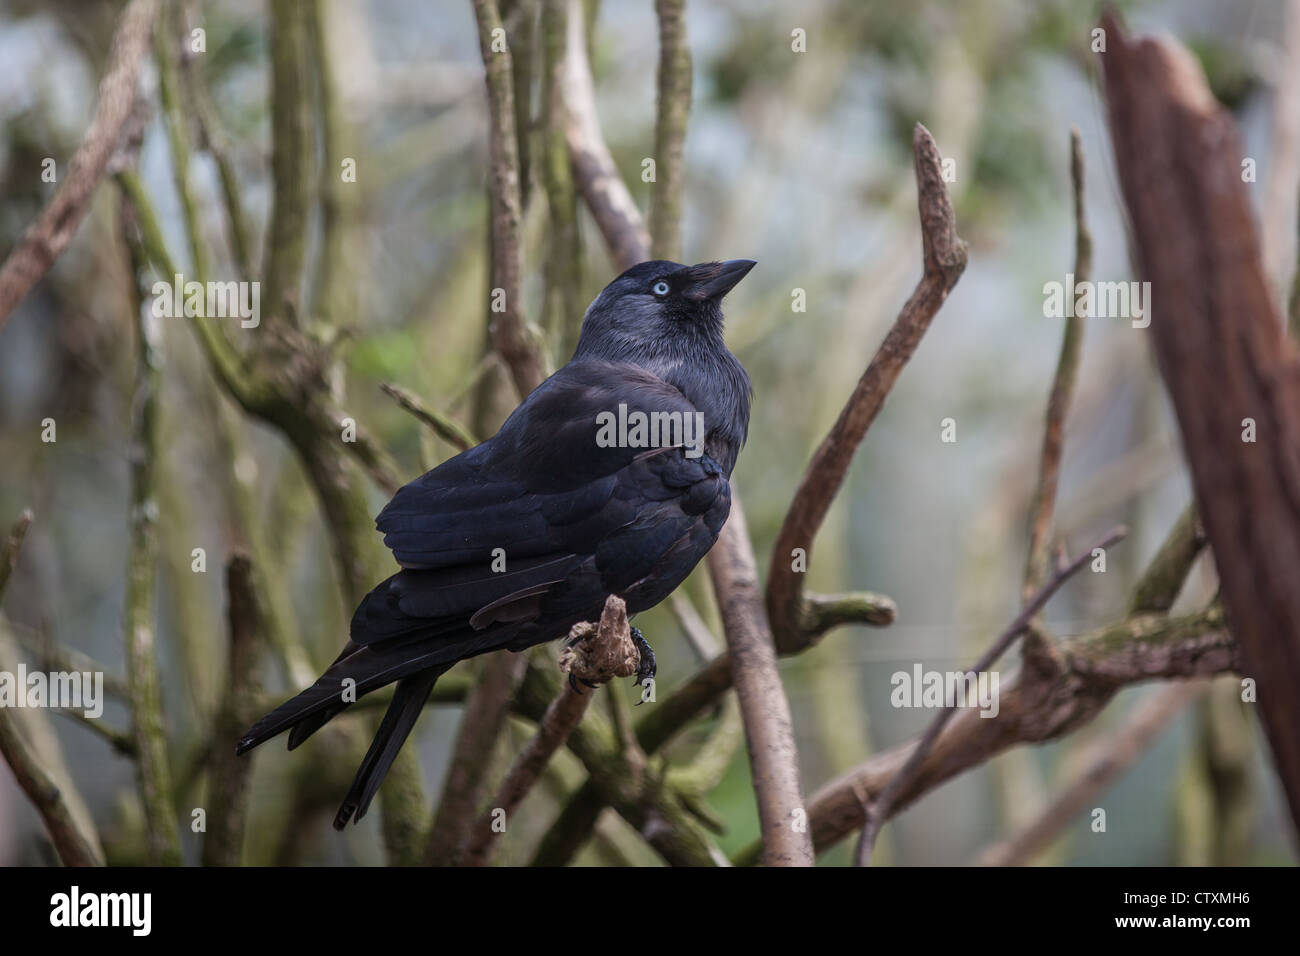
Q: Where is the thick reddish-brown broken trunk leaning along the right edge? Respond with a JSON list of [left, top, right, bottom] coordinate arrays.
[[1102, 14, 1300, 825]]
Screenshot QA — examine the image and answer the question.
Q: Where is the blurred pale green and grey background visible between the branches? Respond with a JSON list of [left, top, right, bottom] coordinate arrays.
[[0, 0, 1291, 865]]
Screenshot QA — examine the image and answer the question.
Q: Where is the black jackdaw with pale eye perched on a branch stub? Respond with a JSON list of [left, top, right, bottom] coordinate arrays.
[[237, 259, 754, 830]]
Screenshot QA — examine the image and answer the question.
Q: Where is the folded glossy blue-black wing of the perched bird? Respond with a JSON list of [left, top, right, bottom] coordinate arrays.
[[352, 363, 729, 644]]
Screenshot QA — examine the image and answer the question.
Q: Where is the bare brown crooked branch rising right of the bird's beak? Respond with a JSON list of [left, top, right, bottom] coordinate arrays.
[[767, 124, 966, 653]]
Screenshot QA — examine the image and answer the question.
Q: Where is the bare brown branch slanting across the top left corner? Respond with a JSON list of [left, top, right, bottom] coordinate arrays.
[[0, 0, 159, 328]]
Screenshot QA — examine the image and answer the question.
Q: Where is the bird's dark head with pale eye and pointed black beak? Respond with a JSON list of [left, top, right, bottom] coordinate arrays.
[[577, 259, 755, 359]]
